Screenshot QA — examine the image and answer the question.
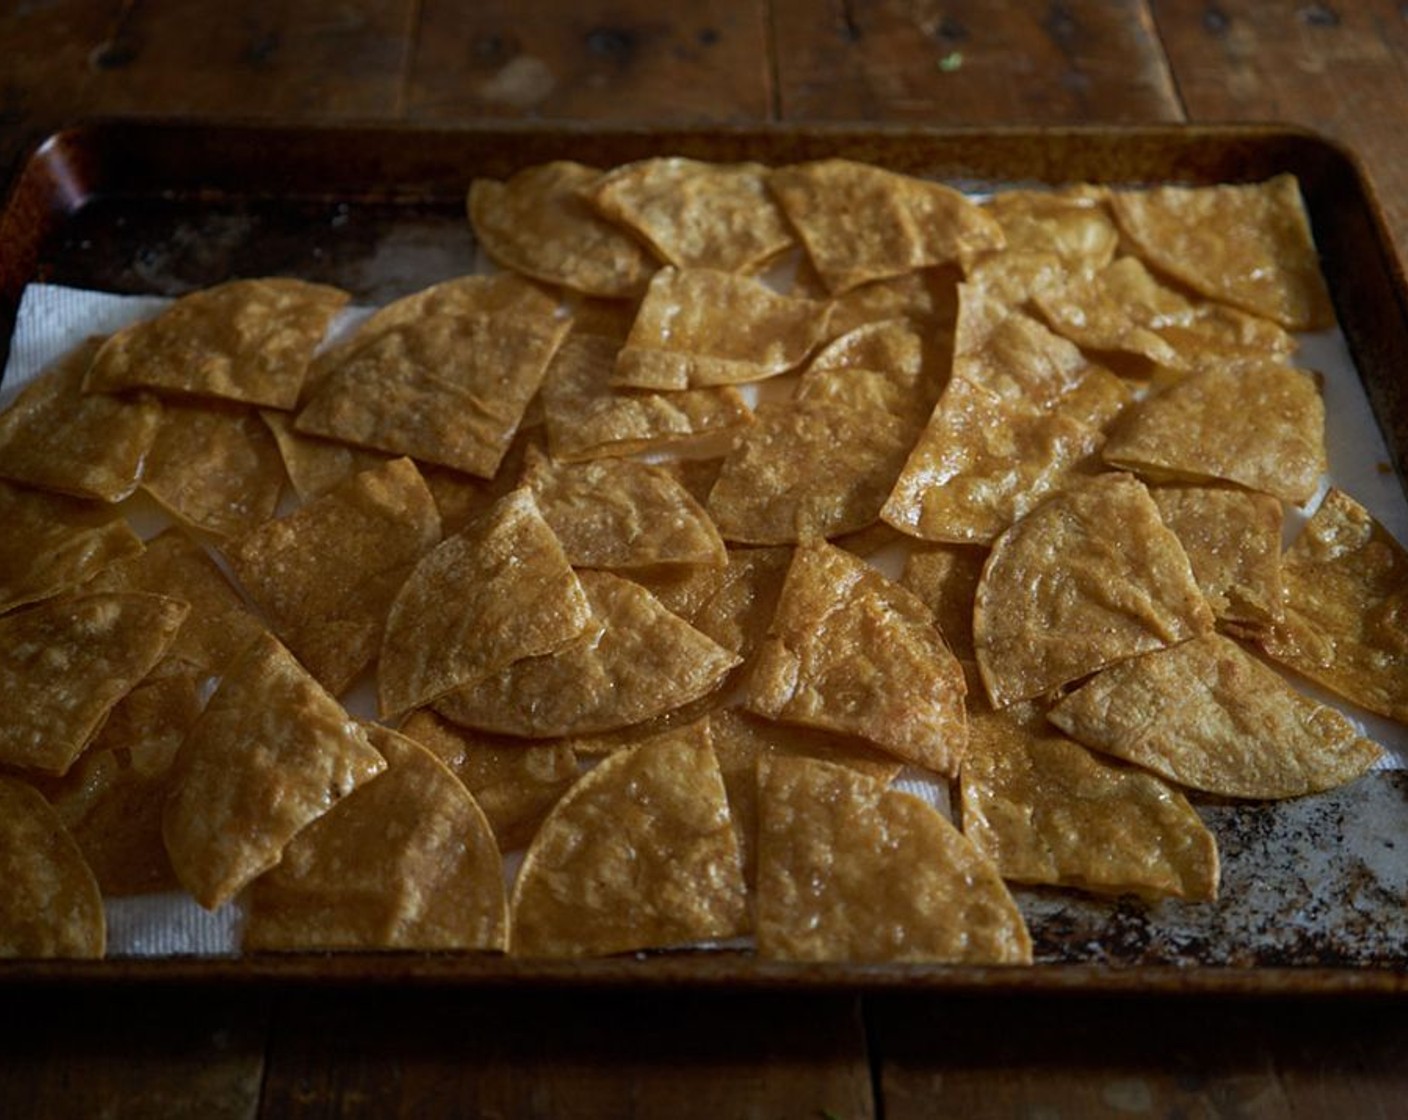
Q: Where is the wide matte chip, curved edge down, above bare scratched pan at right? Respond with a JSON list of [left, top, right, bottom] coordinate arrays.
[[1048, 634, 1383, 799]]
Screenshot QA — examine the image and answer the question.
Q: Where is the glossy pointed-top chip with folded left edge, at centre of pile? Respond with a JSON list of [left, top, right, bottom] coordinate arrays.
[[743, 541, 967, 775]]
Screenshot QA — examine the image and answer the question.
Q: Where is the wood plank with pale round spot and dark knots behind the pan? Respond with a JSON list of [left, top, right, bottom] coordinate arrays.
[[407, 0, 772, 121]]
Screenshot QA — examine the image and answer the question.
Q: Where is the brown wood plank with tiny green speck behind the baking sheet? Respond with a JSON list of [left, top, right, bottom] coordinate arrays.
[[774, 0, 1180, 124]]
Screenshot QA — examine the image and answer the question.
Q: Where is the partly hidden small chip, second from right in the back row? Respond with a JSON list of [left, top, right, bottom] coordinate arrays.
[[984, 186, 1119, 268]]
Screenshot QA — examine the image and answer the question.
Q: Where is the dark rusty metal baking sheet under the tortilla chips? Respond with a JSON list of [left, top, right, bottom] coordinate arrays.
[[0, 121, 1408, 993]]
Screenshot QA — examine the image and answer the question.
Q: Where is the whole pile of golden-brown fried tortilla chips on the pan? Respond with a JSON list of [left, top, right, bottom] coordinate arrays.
[[0, 158, 1408, 964]]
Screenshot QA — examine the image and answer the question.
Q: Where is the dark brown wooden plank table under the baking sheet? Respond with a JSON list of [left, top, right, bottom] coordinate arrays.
[[8, 0, 1408, 1120]]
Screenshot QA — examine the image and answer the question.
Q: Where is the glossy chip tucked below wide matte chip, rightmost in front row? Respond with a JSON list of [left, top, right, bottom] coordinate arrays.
[[959, 704, 1218, 902]]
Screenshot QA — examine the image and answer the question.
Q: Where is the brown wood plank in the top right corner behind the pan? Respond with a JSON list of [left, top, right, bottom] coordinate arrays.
[[1153, 0, 1408, 261]]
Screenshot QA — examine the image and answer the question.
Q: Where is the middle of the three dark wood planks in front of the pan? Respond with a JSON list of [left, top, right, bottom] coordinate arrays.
[[260, 989, 873, 1120]]
